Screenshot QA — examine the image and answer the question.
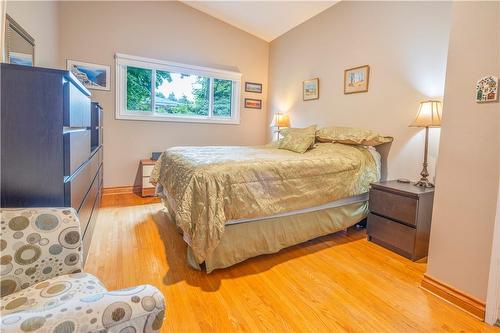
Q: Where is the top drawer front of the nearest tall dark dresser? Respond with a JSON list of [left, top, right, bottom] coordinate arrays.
[[63, 81, 90, 127]]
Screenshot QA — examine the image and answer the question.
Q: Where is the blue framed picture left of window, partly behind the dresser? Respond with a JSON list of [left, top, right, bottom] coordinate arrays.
[[66, 59, 110, 90]]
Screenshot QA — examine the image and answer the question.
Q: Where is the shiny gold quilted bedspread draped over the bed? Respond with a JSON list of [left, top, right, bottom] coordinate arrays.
[[151, 143, 378, 263]]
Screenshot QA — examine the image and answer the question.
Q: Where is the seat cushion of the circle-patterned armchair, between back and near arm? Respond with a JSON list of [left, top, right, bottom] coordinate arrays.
[[0, 273, 107, 319]]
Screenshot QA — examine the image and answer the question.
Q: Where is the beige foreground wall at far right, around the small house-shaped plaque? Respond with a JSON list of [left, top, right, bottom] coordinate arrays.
[[427, 2, 500, 300]]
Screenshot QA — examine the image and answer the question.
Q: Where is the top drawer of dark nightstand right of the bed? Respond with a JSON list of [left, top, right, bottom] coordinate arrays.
[[369, 189, 418, 225]]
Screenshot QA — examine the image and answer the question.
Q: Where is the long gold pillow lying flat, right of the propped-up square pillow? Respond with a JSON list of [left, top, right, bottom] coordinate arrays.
[[316, 127, 393, 146]]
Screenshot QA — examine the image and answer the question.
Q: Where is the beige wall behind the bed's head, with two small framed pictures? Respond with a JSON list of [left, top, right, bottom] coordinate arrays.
[[268, 1, 451, 179]]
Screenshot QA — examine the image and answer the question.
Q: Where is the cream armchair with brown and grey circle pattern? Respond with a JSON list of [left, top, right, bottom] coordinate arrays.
[[0, 208, 165, 333]]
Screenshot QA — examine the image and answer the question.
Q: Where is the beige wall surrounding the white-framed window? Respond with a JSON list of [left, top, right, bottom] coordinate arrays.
[[59, 1, 269, 187]]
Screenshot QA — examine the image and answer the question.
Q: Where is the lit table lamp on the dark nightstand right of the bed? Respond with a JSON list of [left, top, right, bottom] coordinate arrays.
[[410, 101, 442, 187]]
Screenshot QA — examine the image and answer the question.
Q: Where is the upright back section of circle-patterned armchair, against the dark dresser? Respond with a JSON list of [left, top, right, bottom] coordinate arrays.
[[0, 208, 82, 297]]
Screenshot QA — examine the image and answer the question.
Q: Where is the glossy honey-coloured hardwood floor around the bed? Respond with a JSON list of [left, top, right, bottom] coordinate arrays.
[[85, 195, 500, 333]]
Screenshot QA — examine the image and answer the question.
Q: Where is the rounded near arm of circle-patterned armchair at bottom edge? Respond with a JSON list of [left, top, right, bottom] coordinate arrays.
[[1, 285, 165, 333]]
